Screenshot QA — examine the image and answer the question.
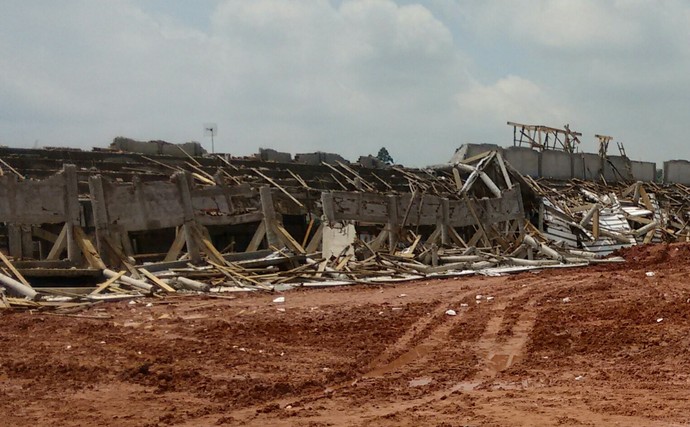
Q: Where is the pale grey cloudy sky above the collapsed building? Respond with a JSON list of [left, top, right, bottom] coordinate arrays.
[[0, 0, 690, 166]]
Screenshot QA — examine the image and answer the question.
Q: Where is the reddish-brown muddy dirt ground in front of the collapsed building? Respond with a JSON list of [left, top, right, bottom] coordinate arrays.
[[0, 245, 690, 427]]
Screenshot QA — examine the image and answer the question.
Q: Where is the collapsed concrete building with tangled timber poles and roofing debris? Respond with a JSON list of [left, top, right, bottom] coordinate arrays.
[[0, 128, 690, 308]]
